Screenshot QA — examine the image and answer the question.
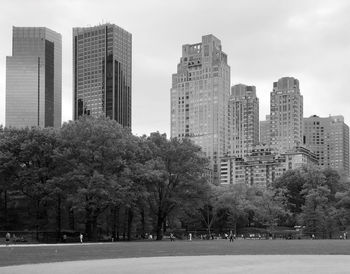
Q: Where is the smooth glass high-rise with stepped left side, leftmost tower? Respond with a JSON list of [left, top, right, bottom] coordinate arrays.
[[5, 27, 62, 127]]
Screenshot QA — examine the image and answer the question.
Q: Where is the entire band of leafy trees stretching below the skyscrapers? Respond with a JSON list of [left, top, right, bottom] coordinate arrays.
[[0, 117, 350, 241]]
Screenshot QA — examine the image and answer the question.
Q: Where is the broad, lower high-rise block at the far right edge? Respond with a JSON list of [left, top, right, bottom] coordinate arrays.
[[303, 115, 350, 176]]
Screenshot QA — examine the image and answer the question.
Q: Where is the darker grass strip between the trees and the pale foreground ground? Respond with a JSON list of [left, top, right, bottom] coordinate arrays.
[[0, 240, 350, 272]]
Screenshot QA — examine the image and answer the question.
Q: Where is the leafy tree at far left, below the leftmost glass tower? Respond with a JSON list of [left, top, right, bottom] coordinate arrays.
[[1, 128, 59, 239]]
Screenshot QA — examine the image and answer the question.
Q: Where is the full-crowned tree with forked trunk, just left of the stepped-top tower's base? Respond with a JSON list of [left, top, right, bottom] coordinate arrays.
[[145, 133, 207, 240]]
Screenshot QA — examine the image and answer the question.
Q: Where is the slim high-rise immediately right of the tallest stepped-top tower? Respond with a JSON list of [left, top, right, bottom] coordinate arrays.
[[228, 84, 259, 158]]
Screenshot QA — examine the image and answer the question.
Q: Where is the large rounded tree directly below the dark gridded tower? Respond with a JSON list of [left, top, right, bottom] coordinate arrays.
[[57, 116, 134, 240]]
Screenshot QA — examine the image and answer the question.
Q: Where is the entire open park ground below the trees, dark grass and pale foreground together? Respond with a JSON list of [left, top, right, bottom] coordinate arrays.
[[0, 240, 350, 274]]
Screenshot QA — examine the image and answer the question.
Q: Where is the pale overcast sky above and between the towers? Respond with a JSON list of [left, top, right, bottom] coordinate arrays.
[[0, 0, 350, 136]]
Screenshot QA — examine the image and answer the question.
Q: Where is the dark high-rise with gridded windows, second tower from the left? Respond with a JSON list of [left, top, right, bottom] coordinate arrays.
[[73, 24, 131, 128]]
